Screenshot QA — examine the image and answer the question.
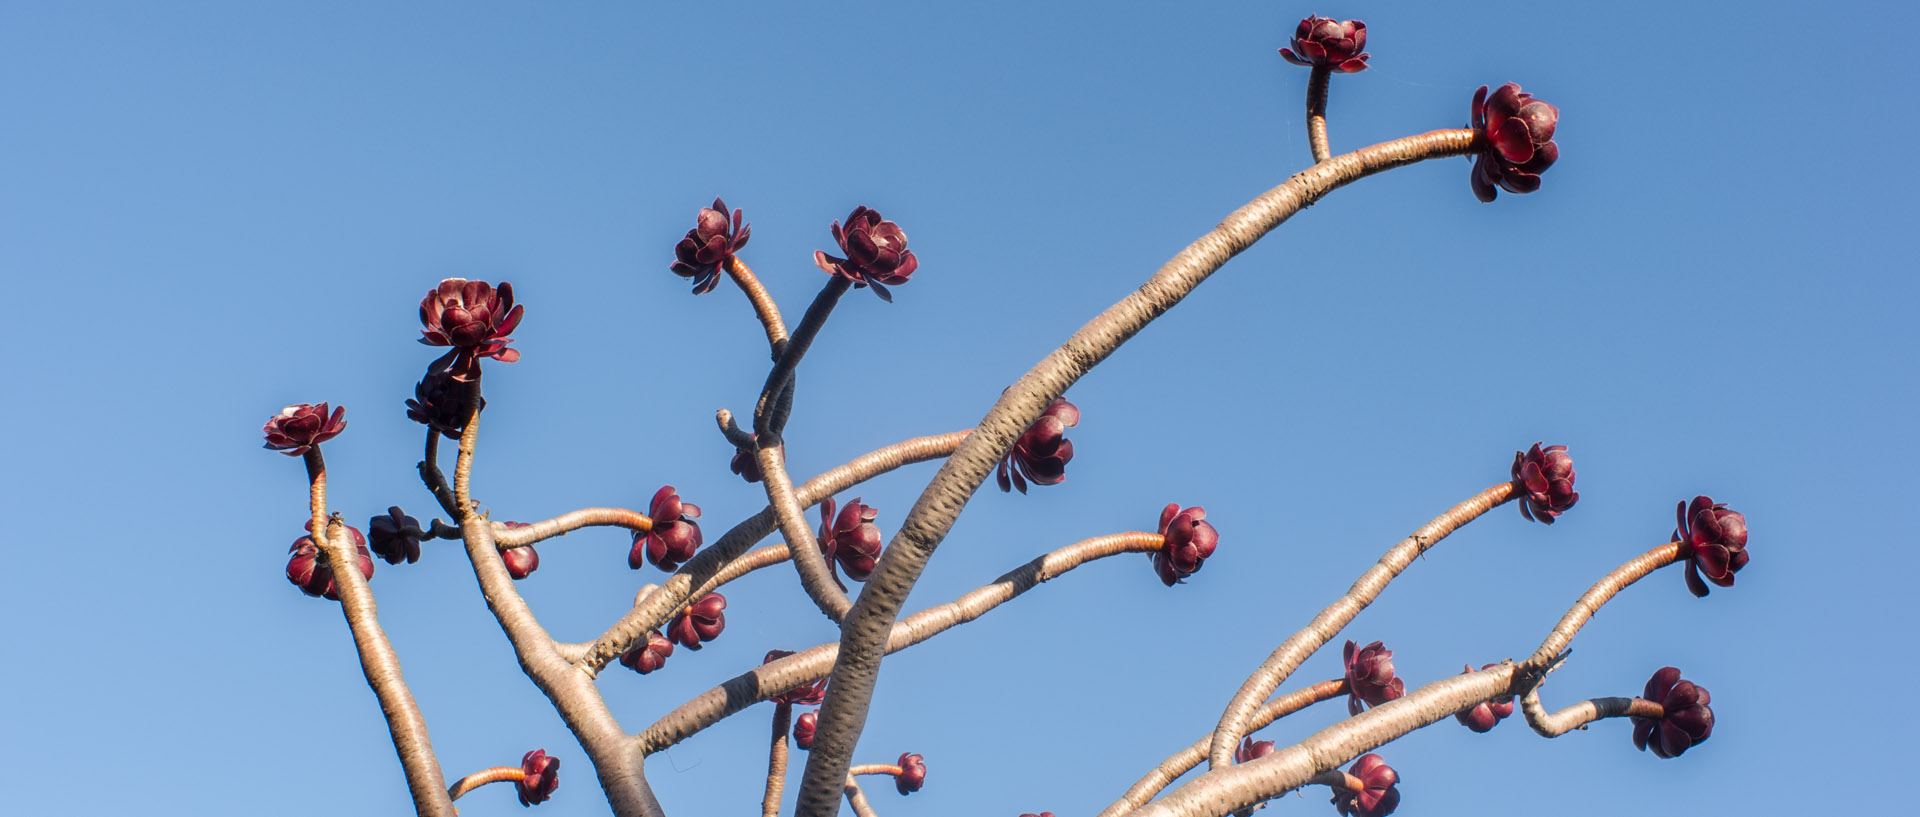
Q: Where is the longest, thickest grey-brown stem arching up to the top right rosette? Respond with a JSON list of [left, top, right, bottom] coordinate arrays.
[[797, 128, 1484, 817]]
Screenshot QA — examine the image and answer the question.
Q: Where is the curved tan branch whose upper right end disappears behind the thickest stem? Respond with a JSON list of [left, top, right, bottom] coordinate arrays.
[[574, 432, 970, 675]]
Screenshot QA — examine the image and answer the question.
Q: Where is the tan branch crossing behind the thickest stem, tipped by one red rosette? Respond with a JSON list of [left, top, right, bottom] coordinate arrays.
[[637, 533, 1162, 751]]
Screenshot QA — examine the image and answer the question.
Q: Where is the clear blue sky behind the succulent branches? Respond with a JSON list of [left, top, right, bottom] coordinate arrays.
[[0, 2, 1920, 817]]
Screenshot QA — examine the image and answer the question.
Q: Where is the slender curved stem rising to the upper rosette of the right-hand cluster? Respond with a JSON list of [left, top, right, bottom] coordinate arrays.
[[1208, 481, 1515, 769]]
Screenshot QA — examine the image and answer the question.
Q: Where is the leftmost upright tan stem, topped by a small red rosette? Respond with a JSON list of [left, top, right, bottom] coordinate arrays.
[[307, 445, 453, 817]]
